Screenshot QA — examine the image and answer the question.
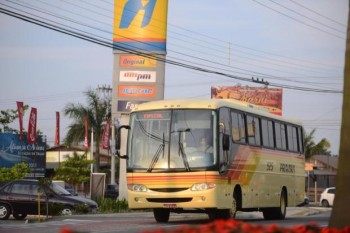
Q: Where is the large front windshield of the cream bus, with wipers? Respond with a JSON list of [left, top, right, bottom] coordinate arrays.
[[128, 109, 216, 172]]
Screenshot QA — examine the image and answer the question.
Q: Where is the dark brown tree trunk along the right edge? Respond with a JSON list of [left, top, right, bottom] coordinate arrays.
[[329, 3, 350, 228]]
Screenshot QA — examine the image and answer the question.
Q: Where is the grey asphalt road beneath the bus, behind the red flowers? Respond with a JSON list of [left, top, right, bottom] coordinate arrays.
[[0, 207, 331, 233]]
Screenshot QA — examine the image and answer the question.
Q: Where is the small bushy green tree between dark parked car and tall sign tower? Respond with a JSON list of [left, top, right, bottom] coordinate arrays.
[[54, 152, 93, 192]]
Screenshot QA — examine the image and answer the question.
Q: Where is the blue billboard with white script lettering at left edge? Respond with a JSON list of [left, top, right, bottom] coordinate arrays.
[[0, 133, 46, 177]]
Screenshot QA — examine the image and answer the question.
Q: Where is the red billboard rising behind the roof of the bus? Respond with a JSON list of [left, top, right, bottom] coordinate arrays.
[[211, 86, 283, 115]]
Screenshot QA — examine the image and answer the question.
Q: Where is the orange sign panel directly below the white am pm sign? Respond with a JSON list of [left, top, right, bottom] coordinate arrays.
[[118, 85, 156, 98]]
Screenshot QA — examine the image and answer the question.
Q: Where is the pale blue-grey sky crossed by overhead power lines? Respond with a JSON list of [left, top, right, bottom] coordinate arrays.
[[0, 0, 349, 154]]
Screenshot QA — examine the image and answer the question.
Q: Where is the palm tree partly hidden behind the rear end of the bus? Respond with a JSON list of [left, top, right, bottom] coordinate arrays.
[[304, 129, 331, 159]]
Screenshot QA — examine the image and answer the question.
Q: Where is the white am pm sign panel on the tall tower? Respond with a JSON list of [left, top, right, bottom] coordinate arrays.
[[119, 71, 156, 83]]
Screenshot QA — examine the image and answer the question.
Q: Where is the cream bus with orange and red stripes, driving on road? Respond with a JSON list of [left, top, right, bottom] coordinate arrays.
[[116, 99, 305, 222]]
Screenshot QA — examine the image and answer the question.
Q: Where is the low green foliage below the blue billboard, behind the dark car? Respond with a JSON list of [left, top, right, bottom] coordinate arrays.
[[0, 162, 30, 182]]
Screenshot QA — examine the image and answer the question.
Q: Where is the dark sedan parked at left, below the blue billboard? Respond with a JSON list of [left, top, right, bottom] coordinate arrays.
[[0, 179, 98, 220]]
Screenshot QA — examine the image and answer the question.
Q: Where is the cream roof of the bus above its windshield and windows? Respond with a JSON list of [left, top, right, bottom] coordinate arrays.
[[132, 99, 301, 125]]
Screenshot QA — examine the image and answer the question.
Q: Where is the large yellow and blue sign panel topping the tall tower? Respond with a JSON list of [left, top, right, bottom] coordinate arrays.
[[113, 0, 168, 51]]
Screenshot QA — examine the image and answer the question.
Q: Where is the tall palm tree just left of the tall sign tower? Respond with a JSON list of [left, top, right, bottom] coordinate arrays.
[[63, 89, 111, 171]]
